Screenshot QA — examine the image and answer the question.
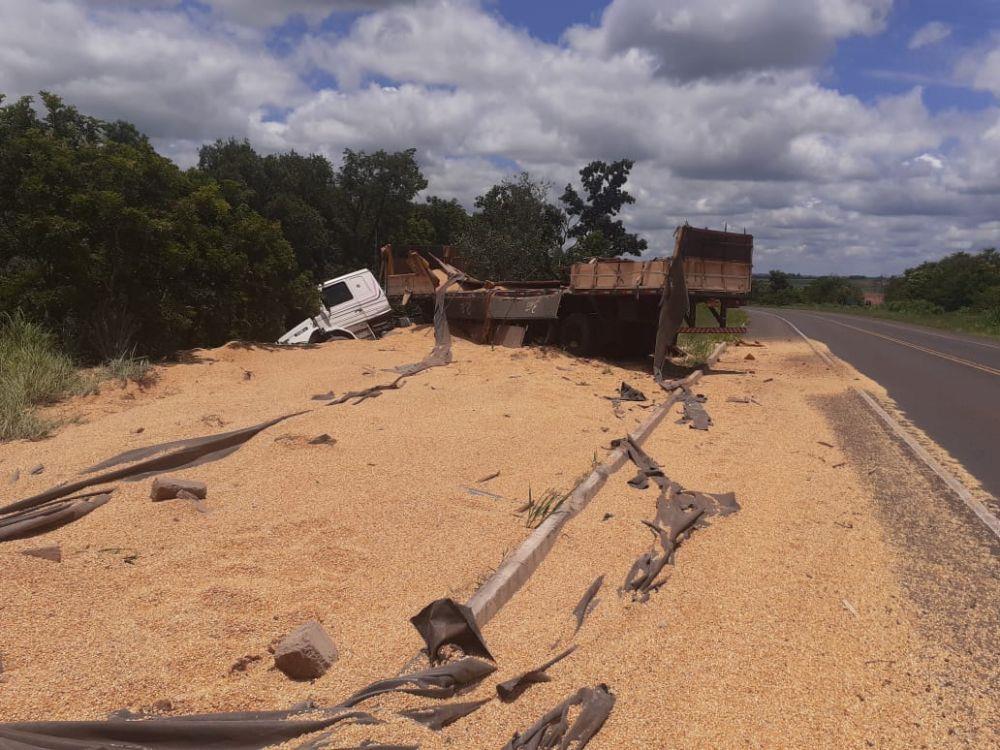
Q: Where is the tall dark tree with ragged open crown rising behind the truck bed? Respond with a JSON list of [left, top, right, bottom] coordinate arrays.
[[560, 159, 647, 265]]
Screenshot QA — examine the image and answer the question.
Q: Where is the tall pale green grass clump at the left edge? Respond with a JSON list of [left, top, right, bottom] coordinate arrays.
[[0, 313, 87, 440]]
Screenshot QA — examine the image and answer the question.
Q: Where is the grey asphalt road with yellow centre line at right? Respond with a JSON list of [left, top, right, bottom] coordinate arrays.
[[748, 309, 1000, 498]]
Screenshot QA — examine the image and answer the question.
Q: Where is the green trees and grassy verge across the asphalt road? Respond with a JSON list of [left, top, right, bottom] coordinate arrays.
[[751, 248, 1000, 336]]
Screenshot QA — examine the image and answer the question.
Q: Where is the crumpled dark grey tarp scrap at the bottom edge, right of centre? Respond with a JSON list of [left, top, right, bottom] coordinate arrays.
[[503, 688, 612, 750]]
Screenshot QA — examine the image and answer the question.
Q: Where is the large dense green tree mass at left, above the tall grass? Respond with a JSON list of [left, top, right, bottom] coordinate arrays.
[[0, 92, 316, 359]]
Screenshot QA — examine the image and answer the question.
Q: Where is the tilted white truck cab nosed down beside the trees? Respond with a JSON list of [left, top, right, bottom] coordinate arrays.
[[278, 268, 394, 344]]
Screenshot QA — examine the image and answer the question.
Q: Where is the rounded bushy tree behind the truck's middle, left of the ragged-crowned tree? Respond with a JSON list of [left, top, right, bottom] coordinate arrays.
[[458, 172, 566, 281]]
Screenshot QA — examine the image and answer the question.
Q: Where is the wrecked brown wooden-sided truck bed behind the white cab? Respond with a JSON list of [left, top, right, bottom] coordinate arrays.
[[382, 226, 753, 356]]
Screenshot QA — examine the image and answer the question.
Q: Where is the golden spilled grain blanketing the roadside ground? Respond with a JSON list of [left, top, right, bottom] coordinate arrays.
[[0, 329, 1000, 750]]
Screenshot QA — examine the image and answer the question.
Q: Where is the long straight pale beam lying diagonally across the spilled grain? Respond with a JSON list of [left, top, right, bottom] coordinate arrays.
[[468, 343, 726, 626]]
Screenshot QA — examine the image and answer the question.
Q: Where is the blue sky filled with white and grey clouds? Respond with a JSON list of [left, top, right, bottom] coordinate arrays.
[[0, 0, 1000, 275]]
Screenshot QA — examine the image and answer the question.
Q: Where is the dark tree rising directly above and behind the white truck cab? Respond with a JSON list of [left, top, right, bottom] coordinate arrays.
[[333, 148, 427, 270]]
